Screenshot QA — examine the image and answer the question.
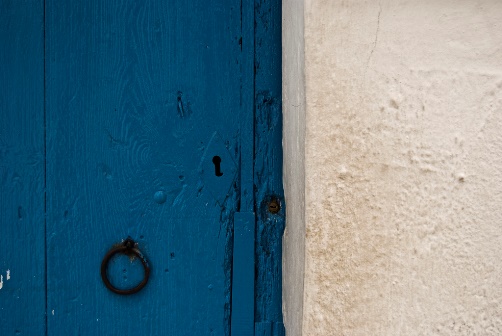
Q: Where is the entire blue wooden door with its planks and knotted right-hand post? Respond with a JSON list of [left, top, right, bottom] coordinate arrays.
[[0, 0, 284, 336]]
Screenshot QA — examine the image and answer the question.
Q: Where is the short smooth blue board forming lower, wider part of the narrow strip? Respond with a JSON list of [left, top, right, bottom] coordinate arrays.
[[232, 212, 255, 336]]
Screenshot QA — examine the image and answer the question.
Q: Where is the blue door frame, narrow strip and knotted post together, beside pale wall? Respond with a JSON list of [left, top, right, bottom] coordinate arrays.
[[231, 0, 286, 336]]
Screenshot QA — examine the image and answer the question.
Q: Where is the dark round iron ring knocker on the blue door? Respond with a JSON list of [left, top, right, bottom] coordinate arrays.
[[101, 237, 150, 295]]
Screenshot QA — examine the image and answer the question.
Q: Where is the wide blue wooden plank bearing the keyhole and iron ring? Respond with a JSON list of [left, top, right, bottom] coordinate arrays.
[[44, 0, 245, 336]]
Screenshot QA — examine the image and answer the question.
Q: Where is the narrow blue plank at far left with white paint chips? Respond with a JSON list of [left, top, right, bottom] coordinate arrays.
[[0, 0, 45, 335]]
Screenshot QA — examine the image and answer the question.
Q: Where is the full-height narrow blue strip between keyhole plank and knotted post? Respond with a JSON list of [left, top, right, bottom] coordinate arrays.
[[231, 1, 256, 336]]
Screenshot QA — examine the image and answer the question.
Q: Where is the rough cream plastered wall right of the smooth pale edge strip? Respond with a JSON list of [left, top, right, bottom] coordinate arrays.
[[303, 0, 502, 335]]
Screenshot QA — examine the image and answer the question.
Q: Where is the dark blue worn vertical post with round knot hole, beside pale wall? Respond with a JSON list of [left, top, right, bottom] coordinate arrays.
[[254, 0, 285, 336]]
